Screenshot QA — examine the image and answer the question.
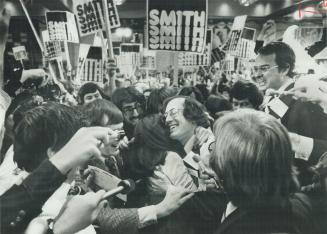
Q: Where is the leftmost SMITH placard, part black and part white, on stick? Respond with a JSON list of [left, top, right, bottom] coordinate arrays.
[[46, 11, 79, 43]]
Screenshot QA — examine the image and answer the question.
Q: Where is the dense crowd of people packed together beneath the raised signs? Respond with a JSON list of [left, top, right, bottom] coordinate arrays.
[[0, 0, 327, 234]]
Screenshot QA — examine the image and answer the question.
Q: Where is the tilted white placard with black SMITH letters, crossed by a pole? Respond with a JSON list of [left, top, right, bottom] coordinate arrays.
[[73, 0, 120, 36]]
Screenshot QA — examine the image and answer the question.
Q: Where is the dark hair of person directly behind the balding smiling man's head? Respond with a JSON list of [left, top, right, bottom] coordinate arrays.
[[147, 87, 177, 114]]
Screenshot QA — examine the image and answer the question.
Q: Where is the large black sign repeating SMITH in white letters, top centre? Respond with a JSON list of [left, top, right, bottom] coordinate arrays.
[[147, 0, 208, 53]]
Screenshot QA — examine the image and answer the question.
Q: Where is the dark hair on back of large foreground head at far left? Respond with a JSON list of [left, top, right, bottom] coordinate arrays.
[[14, 103, 86, 172]]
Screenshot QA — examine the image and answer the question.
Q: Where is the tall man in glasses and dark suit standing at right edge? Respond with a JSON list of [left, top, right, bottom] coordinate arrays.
[[254, 42, 327, 183]]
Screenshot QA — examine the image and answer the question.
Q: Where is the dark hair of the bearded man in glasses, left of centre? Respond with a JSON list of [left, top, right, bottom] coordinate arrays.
[[111, 86, 145, 110]]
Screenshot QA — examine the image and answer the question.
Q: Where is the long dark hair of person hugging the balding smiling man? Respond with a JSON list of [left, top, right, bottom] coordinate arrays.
[[122, 114, 183, 179]]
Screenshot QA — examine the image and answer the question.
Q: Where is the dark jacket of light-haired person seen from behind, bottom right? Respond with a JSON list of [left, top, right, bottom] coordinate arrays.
[[214, 194, 319, 234]]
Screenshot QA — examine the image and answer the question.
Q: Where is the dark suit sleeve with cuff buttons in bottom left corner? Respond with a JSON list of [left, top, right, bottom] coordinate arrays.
[[0, 160, 66, 234]]
